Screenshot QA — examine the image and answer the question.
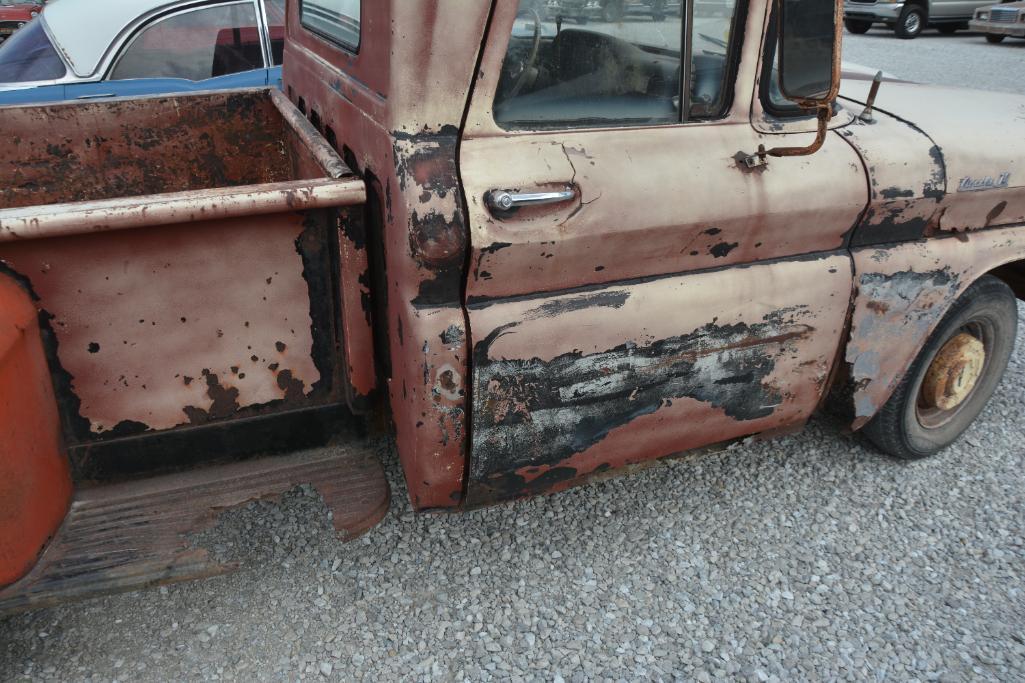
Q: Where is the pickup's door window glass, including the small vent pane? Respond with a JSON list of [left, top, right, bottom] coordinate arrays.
[[494, 0, 736, 128]]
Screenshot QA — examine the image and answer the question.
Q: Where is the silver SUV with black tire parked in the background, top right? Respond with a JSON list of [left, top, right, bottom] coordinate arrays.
[[844, 0, 993, 38]]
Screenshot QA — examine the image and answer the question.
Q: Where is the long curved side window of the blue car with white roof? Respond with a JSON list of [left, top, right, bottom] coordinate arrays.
[[111, 2, 263, 81]]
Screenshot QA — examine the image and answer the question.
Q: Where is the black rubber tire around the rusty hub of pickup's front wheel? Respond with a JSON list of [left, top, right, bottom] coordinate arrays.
[[862, 275, 1018, 460]]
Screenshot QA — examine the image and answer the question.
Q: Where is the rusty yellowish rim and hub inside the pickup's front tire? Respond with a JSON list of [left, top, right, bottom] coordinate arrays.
[[915, 322, 992, 429]]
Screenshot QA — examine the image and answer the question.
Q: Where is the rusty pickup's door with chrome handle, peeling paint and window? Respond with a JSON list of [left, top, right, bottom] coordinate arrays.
[[459, 2, 867, 505]]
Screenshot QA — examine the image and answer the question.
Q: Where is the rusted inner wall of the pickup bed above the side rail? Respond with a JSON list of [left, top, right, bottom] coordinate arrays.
[[0, 89, 338, 209]]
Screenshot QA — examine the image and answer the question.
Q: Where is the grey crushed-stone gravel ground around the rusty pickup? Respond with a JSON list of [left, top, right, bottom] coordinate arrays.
[[0, 30, 1025, 682]]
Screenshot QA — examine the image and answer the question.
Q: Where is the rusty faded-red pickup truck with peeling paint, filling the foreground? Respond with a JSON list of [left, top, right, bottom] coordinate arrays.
[[0, 0, 1025, 610]]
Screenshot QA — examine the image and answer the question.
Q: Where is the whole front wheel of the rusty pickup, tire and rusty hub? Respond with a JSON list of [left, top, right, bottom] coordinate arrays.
[[863, 275, 1018, 459]]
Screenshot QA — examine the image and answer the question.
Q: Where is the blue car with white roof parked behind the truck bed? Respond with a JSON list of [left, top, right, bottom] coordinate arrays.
[[0, 0, 285, 105]]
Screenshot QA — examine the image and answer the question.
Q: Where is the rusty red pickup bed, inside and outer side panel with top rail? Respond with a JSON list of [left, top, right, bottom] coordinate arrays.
[[0, 88, 369, 481]]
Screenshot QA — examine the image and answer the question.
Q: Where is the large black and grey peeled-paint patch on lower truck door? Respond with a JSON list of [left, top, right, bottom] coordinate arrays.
[[470, 307, 813, 497]]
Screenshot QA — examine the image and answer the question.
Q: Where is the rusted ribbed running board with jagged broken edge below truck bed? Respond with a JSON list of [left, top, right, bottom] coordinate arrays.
[[0, 444, 391, 614]]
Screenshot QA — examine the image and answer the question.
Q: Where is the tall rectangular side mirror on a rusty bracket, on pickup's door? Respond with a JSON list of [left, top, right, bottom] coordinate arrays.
[[741, 0, 844, 168]]
